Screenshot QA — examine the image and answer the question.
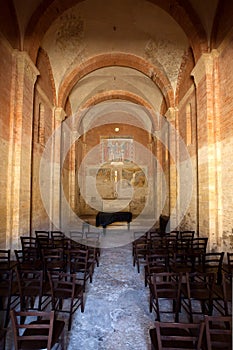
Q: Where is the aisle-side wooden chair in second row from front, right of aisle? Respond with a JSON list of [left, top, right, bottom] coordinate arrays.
[[150, 272, 181, 322]]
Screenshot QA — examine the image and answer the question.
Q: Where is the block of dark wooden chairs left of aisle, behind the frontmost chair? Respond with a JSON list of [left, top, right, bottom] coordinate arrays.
[[0, 228, 99, 329]]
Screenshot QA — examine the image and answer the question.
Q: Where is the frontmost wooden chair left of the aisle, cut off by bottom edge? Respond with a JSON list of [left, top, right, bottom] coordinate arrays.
[[11, 310, 65, 350]]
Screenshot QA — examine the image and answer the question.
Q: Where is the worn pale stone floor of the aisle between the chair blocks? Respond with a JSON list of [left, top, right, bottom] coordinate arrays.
[[67, 244, 154, 350]]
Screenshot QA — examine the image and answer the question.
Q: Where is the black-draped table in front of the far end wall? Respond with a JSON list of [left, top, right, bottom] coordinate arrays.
[[96, 211, 132, 228]]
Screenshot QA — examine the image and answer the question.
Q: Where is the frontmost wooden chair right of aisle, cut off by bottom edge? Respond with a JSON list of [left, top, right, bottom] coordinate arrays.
[[150, 321, 204, 350]]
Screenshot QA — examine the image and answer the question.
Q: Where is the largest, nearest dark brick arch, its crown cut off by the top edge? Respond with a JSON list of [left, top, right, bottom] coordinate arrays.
[[24, 0, 208, 63]]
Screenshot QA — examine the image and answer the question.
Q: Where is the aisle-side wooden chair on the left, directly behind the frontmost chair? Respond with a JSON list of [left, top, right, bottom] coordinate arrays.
[[48, 271, 84, 330]]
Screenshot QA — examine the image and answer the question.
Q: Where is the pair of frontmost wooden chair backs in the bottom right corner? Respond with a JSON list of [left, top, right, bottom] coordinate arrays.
[[149, 315, 232, 350]]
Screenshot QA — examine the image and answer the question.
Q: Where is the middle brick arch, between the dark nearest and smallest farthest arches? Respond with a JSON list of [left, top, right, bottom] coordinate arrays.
[[58, 52, 174, 107]]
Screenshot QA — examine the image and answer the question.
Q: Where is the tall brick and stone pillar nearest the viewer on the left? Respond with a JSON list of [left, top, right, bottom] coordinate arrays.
[[7, 50, 39, 250]]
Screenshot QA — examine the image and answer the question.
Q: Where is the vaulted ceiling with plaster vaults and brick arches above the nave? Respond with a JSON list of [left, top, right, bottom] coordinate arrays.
[[10, 0, 218, 119]]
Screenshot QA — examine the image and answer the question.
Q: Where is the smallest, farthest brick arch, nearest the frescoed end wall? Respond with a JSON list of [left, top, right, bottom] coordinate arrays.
[[75, 90, 158, 132]]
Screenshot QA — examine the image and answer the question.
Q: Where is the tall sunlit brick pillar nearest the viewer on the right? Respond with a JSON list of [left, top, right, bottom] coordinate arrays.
[[192, 50, 221, 250]]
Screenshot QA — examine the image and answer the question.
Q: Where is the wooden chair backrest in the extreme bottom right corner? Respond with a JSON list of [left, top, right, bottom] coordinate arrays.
[[205, 315, 232, 350]]
